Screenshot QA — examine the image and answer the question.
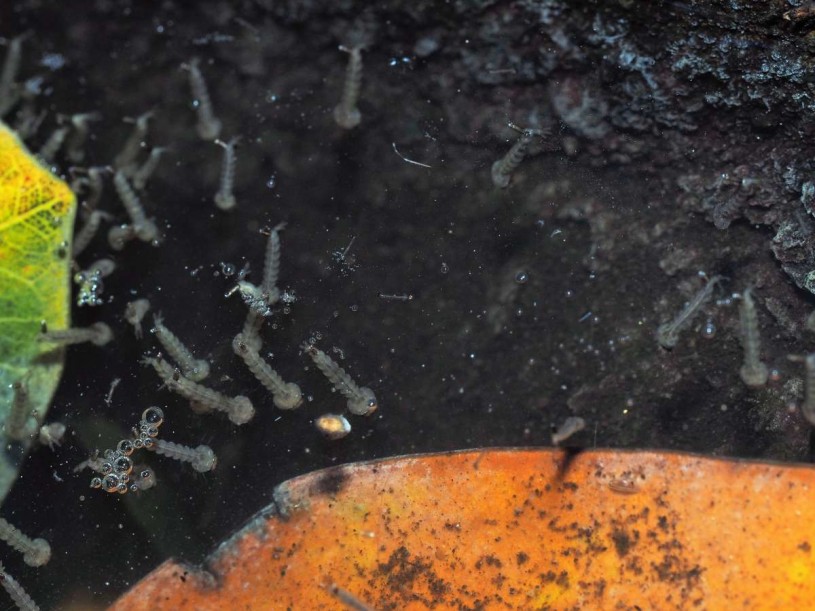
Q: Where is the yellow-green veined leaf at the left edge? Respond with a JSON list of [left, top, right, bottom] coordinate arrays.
[[0, 122, 76, 501]]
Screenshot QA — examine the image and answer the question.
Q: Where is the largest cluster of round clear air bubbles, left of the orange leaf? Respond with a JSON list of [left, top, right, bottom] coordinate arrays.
[[91, 407, 164, 494]]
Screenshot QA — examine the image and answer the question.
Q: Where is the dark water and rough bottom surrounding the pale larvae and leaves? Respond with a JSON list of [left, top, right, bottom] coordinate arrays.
[[0, 0, 815, 608]]
